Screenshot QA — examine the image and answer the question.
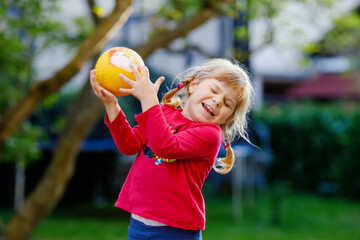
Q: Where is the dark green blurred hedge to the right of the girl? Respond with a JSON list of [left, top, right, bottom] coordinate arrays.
[[255, 103, 360, 198]]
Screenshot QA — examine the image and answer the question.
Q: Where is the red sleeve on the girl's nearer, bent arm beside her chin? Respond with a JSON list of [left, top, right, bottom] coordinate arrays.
[[135, 105, 222, 160]]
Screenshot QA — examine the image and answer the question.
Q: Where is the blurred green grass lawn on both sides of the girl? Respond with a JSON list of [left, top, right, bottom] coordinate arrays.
[[1, 194, 360, 240]]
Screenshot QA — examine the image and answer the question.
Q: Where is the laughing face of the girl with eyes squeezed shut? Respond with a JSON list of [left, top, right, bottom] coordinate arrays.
[[182, 78, 239, 125]]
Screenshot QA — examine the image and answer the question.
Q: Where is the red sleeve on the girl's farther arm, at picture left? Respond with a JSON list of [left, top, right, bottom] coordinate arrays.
[[104, 111, 146, 155]]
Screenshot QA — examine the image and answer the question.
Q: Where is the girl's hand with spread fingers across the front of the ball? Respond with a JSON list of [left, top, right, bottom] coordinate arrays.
[[119, 65, 165, 103]]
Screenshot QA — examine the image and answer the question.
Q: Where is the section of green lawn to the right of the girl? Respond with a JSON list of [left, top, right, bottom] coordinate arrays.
[[203, 195, 360, 240]]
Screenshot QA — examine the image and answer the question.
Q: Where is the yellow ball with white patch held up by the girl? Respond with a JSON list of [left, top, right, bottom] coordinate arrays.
[[95, 47, 145, 97]]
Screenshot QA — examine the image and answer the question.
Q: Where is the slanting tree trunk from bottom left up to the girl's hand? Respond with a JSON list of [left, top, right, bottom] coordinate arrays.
[[6, 83, 103, 240]]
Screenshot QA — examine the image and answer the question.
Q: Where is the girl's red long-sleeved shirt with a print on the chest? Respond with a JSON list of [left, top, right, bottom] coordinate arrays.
[[105, 105, 222, 230]]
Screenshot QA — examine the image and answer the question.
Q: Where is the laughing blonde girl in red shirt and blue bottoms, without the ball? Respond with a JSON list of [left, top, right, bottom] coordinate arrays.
[[90, 59, 253, 239]]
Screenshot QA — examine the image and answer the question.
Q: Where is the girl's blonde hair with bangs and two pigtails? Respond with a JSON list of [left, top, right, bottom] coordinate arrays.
[[162, 58, 254, 174]]
